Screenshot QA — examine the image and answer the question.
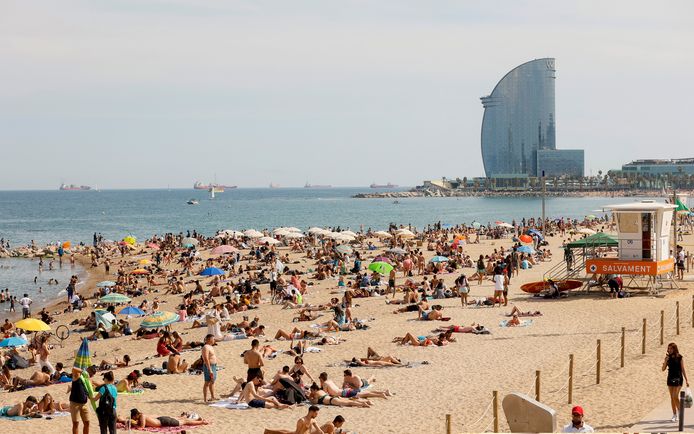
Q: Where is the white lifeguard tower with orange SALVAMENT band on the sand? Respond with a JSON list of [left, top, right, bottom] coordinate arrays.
[[586, 200, 676, 293]]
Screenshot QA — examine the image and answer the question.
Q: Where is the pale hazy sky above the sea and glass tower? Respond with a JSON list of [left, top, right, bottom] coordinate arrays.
[[0, 0, 694, 189]]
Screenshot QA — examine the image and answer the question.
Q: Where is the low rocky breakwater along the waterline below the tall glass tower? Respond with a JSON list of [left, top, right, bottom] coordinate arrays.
[[352, 188, 680, 199]]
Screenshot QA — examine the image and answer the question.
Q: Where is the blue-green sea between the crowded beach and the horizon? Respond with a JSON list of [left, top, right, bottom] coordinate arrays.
[[0, 188, 664, 312]]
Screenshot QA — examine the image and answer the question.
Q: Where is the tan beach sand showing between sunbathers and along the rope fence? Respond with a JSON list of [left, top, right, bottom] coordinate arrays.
[[0, 229, 694, 434]]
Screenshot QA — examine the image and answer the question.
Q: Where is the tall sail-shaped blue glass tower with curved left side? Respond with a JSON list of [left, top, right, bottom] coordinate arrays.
[[481, 58, 560, 178]]
